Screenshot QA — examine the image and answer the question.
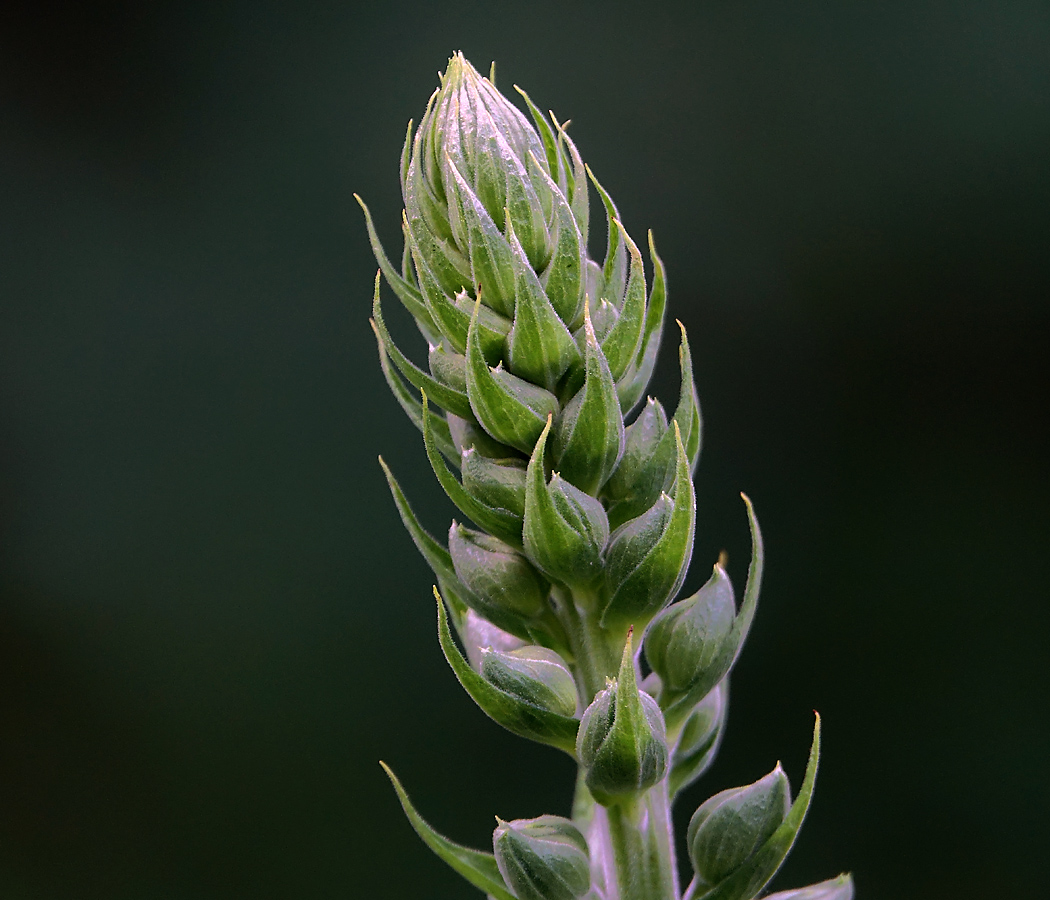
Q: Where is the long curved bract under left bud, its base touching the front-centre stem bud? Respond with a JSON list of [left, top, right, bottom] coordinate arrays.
[[434, 588, 580, 756]]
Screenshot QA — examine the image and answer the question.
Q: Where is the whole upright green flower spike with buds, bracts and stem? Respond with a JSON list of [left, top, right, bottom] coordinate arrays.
[[358, 55, 853, 900]]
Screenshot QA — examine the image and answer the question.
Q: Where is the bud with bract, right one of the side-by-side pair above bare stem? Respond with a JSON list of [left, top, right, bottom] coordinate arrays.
[[602, 423, 696, 627]]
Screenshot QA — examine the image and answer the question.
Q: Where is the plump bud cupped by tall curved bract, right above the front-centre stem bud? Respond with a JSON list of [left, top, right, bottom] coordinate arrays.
[[645, 563, 736, 694]]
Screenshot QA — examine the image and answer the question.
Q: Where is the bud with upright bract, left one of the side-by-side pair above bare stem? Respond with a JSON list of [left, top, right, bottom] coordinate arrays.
[[522, 419, 609, 586]]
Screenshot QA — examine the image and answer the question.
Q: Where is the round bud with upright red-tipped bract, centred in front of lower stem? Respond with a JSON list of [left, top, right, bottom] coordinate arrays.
[[576, 632, 668, 805]]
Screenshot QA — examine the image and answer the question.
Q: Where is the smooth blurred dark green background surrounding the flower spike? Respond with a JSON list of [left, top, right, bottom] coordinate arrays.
[[0, 0, 1050, 900]]
